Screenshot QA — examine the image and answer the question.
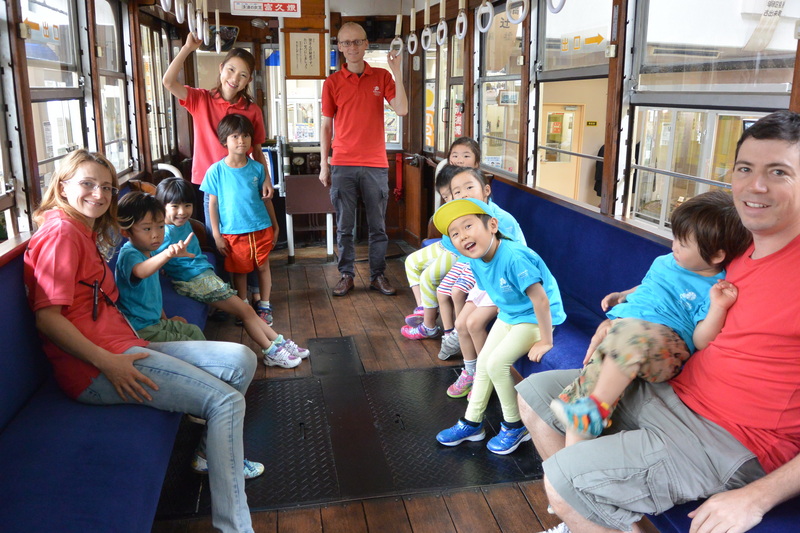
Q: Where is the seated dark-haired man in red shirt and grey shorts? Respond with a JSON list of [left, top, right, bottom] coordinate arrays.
[[517, 111, 800, 533]]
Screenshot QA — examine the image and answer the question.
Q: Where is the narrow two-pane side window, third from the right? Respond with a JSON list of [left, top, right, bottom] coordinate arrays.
[[476, 5, 523, 177]]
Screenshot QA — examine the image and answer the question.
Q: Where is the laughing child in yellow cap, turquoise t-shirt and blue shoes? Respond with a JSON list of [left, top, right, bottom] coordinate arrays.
[[433, 198, 566, 455]]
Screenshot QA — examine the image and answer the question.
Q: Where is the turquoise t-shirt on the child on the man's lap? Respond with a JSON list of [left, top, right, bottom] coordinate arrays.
[[606, 254, 725, 352]]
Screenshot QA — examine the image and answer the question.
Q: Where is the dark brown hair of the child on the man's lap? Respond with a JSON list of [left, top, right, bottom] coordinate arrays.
[[670, 190, 752, 268]]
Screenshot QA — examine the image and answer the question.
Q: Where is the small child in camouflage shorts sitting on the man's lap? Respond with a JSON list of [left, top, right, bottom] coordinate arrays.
[[550, 190, 751, 445]]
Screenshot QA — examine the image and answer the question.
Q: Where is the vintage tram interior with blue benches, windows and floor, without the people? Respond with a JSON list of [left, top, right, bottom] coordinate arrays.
[[0, 0, 800, 532]]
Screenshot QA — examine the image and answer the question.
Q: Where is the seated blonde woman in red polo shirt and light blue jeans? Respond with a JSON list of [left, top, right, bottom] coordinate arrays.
[[24, 150, 264, 532]]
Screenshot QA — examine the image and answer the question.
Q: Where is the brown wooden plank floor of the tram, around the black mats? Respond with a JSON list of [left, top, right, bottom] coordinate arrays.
[[153, 242, 656, 533]]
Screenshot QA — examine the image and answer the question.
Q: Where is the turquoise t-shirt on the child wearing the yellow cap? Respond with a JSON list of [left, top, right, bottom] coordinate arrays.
[[468, 239, 567, 326]]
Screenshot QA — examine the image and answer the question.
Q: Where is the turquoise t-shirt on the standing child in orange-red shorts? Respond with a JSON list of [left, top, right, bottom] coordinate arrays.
[[200, 159, 272, 235]]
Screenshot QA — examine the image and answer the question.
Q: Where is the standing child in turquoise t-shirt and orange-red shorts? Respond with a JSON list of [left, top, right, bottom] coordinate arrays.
[[200, 114, 275, 326]]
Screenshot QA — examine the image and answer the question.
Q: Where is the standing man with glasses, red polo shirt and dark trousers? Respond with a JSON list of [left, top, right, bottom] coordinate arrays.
[[319, 22, 408, 296]]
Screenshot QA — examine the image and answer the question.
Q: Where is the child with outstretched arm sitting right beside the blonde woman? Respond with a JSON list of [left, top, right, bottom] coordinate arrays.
[[115, 192, 206, 342]]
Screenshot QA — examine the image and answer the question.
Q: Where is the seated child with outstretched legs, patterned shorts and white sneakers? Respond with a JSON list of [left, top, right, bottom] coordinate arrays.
[[156, 178, 309, 368]]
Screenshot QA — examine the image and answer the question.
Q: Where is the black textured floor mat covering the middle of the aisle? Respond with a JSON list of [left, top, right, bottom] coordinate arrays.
[[158, 338, 542, 518]]
